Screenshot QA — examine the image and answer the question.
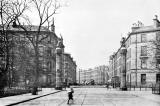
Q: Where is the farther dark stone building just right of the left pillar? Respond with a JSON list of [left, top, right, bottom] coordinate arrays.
[[63, 53, 77, 85]]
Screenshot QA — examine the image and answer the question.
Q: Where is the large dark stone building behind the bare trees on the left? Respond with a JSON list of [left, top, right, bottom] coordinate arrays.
[[0, 19, 59, 87]]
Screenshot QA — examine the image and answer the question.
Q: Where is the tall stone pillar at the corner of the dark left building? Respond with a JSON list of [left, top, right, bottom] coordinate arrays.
[[55, 41, 64, 90]]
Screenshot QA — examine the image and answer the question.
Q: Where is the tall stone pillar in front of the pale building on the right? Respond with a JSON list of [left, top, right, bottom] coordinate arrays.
[[120, 46, 127, 91]]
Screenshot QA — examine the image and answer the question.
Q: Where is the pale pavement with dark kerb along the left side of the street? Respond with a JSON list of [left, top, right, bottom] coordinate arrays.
[[0, 88, 61, 106]]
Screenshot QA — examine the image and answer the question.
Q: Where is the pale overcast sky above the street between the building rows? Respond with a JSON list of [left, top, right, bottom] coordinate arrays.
[[55, 0, 160, 69]]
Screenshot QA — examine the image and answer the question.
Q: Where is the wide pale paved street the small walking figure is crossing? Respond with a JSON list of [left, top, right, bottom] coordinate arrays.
[[16, 88, 160, 106]]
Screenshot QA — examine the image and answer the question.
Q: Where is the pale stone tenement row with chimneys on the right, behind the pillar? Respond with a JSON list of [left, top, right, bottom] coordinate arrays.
[[109, 16, 160, 86]]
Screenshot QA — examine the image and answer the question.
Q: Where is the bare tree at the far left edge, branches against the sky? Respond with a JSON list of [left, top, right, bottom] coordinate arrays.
[[0, 0, 28, 89]]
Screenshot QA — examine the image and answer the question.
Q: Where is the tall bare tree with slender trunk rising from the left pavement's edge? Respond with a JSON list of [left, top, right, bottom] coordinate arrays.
[[16, 0, 61, 95]]
